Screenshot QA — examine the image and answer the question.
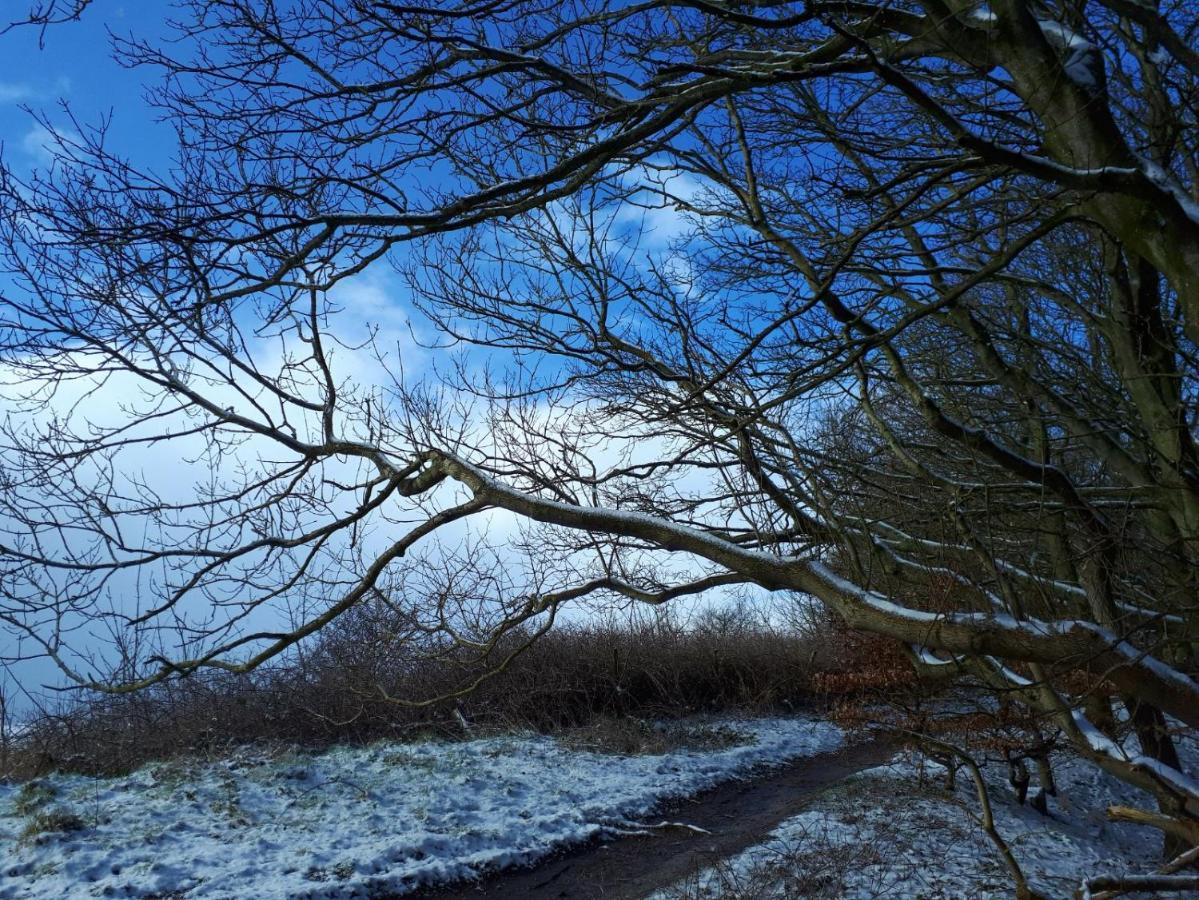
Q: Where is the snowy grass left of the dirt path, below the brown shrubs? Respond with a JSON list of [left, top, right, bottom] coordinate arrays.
[[0, 718, 842, 900]]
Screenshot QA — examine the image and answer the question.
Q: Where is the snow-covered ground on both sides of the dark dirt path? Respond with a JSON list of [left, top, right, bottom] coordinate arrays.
[[0, 718, 1199, 900]]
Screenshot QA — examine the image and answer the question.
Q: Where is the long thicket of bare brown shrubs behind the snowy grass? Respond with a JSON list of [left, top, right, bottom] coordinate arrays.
[[7, 608, 848, 778]]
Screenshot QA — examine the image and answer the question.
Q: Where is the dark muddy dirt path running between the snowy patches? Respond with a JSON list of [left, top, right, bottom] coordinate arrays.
[[415, 742, 893, 900]]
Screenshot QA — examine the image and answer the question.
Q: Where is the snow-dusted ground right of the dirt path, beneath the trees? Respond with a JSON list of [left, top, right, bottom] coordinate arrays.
[[653, 741, 1199, 900]]
